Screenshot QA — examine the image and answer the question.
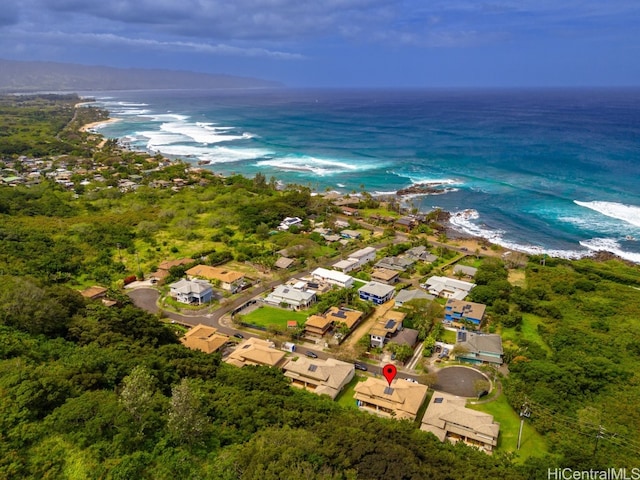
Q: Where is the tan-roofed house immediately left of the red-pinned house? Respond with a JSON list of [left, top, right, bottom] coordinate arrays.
[[282, 357, 355, 400]]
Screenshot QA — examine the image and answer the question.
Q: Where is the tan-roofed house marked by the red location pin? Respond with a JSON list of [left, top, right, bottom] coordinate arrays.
[[353, 377, 428, 420]]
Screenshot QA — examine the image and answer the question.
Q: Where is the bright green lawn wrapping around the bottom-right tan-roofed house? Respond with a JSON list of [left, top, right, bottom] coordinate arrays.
[[468, 395, 547, 461]]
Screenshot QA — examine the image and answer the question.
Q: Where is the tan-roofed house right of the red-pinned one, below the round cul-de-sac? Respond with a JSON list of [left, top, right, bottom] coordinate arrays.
[[420, 392, 500, 453]]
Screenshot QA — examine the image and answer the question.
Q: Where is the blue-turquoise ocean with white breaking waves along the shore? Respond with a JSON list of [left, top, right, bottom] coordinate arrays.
[[91, 89, 640, 263]]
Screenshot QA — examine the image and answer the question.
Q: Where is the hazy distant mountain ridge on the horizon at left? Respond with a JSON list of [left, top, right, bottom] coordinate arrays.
[[0, 59, 282, 93]]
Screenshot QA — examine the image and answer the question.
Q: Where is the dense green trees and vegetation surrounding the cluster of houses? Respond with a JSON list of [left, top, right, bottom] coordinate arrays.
[[0, 97, 640, 479]]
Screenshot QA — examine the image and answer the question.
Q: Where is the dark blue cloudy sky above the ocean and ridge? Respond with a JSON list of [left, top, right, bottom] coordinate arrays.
[[0, 0, 640, 87]]
